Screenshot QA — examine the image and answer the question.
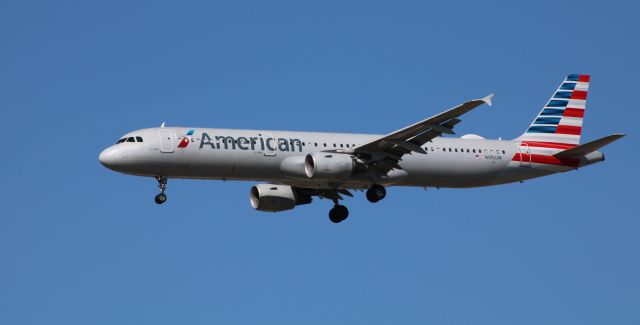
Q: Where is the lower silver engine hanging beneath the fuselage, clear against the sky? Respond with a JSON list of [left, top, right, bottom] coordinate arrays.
[[249, 184, 311, 212]]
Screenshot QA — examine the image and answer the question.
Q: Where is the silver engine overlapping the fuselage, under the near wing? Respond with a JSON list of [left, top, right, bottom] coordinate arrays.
[[304, 152, 355, 179]]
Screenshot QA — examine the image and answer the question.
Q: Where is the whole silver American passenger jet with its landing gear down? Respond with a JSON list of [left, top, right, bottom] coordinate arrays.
[[99, 74, 624, 223]]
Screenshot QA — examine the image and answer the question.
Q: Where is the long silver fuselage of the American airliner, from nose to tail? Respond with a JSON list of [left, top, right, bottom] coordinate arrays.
[[100, 127, 604, 189]]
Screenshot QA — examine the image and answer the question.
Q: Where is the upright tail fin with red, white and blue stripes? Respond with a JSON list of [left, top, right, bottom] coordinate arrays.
[[516, 74, 589, 145]]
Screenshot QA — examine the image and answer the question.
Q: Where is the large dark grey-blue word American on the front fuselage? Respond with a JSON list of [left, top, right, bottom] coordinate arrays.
[[199, 130, 302, 152]]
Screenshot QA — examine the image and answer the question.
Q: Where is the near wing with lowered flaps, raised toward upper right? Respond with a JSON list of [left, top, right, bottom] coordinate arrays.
[[353, 94, 493, 174]]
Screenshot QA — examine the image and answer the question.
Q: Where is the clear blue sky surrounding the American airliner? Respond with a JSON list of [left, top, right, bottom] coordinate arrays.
[[0, 1, 640, 325]]
